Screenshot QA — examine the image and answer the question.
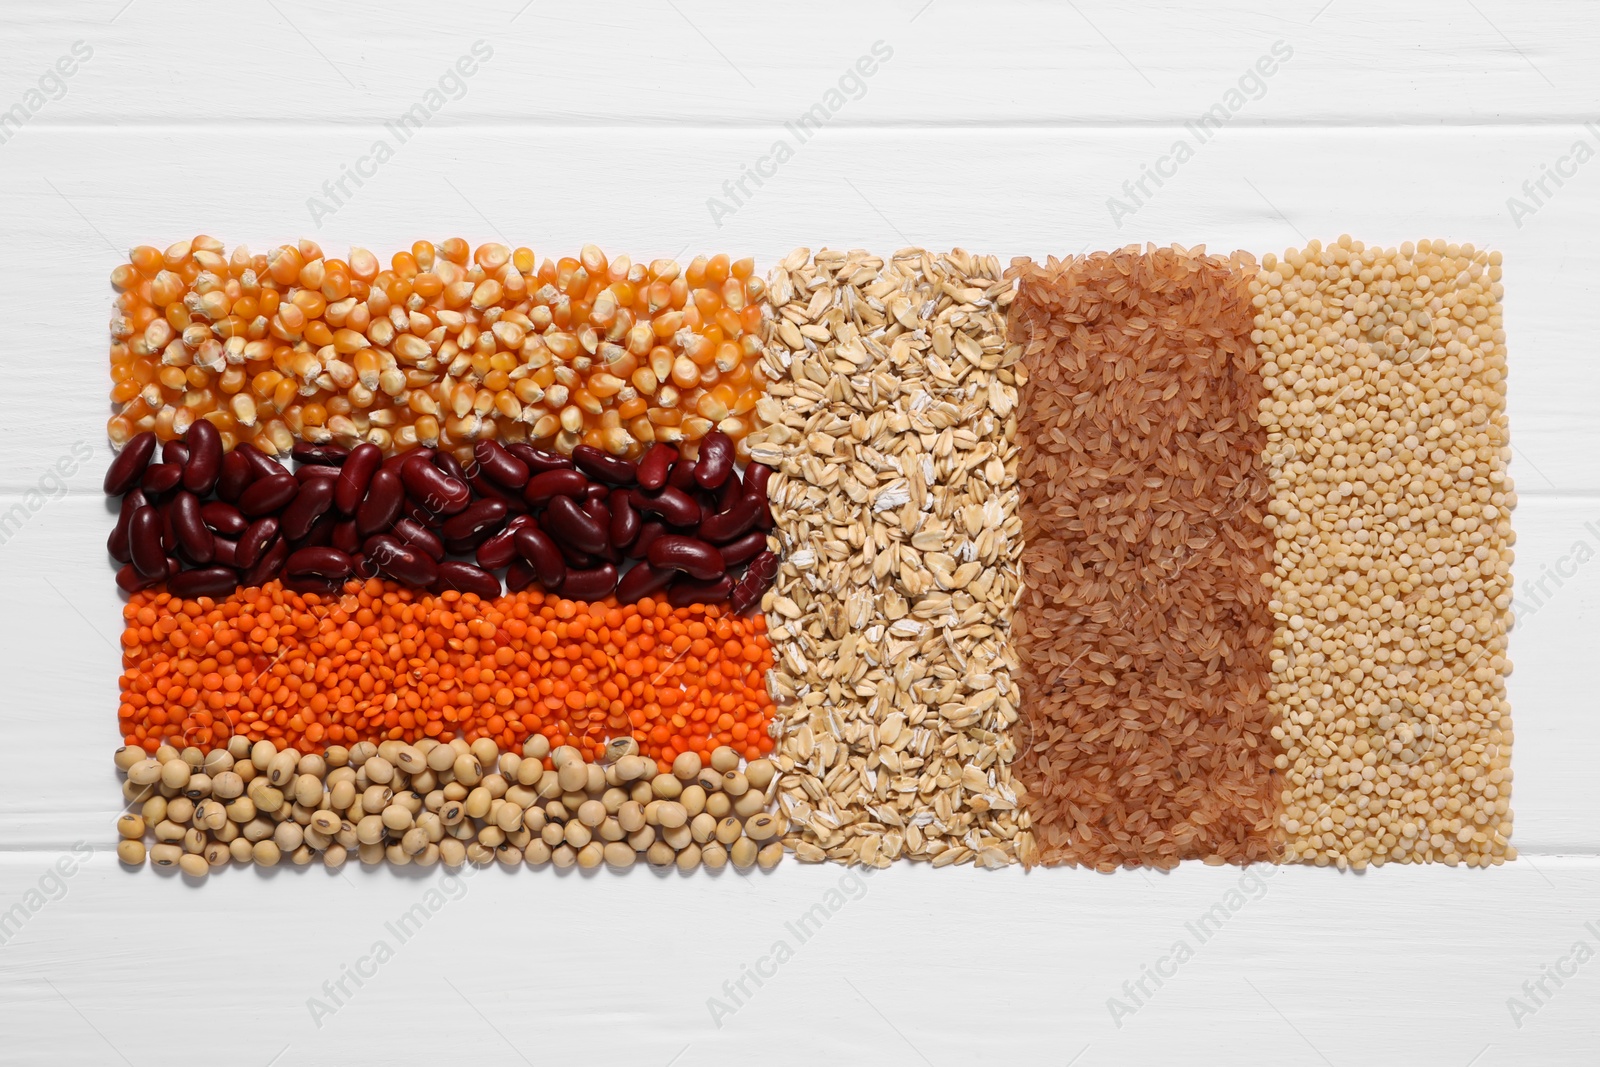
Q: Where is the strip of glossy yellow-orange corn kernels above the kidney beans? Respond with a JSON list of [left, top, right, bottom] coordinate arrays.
[[106, 243, 765, 459]]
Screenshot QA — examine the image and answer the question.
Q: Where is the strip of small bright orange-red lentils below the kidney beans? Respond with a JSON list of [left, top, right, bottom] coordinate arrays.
[[118, 579, 773, 769]]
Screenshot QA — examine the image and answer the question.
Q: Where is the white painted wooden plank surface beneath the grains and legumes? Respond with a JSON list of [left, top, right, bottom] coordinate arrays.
[[0, 0, 1600, 1067]]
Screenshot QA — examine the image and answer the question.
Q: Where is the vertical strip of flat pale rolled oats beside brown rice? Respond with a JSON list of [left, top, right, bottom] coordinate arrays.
[[750, 248, 1035, 867]]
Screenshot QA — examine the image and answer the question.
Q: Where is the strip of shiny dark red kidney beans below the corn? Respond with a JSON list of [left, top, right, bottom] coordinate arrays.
[[106, 419, 778, 613]]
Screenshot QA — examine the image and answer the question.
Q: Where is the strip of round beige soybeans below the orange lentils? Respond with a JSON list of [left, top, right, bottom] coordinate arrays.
[[117, 734, 782, 878]]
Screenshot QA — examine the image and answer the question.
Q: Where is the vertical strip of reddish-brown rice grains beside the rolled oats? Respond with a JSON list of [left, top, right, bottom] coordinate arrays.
[[1010, 248, 1280, 870]]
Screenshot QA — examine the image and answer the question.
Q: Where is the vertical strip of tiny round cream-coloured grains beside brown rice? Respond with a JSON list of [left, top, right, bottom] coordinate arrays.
[[1254, 237, 1517, 869]]
